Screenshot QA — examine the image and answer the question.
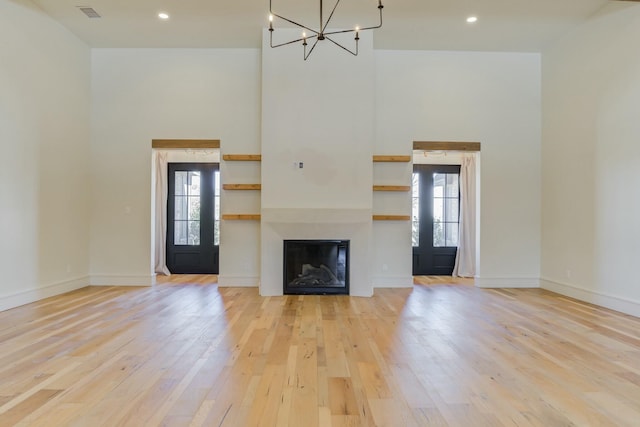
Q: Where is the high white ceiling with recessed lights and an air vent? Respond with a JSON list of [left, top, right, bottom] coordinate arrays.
[[28, 0, 640, 52]]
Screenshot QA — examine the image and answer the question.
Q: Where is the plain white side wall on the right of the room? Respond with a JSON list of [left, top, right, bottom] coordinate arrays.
[[541, 3, 640, 316]]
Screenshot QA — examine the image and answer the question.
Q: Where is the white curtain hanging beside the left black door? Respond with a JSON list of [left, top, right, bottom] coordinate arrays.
[[153, 151, 171, 276]]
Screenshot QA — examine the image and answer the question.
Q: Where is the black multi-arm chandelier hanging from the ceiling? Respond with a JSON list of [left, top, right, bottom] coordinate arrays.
[[269, 0, 384, 61]]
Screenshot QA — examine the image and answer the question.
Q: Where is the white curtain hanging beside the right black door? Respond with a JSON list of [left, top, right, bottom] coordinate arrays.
[[452, 154, 476, 277]]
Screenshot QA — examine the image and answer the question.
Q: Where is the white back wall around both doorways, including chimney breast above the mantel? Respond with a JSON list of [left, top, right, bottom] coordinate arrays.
[[91, 46, 540, 292]]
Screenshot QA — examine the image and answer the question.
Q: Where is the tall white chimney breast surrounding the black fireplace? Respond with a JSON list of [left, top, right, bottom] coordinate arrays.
[[260, 29, 375, 296]]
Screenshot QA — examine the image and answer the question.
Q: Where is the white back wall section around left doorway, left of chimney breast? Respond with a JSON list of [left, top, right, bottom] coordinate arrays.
[[91, 49, 260, 284]]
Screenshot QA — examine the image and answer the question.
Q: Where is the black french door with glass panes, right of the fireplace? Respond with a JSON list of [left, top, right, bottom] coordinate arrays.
[[411, 164, 460, 276]]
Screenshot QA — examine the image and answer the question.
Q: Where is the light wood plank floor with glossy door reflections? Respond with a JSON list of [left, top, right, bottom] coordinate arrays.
[[0, 276, 640, 427]]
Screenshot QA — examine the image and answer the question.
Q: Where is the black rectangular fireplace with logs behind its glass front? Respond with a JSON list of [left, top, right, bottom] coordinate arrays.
[[283, 240, 349, 295]]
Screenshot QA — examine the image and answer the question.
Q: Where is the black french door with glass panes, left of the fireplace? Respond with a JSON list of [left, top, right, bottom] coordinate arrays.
[[167, 163, 220, 274]]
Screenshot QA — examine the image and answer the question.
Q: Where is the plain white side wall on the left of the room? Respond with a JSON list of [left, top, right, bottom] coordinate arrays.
[[0, 1, 90, 310]]
